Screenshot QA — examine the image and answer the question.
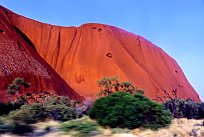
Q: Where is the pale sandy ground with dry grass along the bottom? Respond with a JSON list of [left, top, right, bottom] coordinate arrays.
[[0, 119, 204, 137]]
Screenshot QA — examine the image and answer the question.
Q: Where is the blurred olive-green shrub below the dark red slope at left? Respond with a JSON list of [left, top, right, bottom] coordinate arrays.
[[9, 96, 76, 124]]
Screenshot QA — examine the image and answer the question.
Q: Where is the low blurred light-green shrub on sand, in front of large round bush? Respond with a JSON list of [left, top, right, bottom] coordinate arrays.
[[60, 116, 100, 137]]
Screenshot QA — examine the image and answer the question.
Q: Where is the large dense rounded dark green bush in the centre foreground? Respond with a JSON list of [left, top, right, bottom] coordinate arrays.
[[89, 92, 171, 129]]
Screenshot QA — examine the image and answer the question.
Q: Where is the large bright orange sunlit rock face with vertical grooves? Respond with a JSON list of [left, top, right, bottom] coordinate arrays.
[[0, 5, 200, 101]]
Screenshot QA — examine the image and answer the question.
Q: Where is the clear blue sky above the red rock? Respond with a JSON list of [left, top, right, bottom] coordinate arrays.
[[0, 0, 204, 100]]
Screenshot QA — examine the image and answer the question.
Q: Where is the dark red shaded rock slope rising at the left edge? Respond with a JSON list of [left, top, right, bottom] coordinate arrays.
[[0, 7, 82, 101]]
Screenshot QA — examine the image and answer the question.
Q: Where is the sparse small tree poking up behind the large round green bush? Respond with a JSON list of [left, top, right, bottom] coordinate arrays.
[[97, 77, 144, 96]]
